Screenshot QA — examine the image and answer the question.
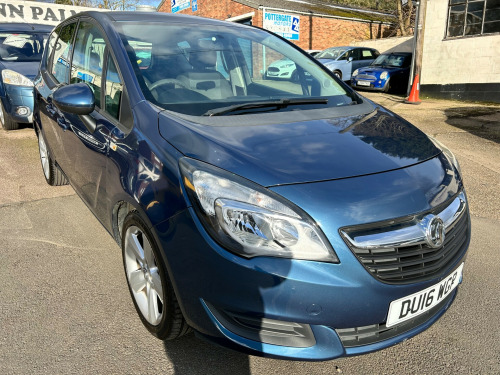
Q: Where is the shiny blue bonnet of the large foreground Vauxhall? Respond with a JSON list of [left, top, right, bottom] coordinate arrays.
[[159, 100, 440, 186]]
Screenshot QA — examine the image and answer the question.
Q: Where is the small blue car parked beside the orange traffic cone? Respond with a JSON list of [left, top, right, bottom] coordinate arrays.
[[351, 52, 412, 93]]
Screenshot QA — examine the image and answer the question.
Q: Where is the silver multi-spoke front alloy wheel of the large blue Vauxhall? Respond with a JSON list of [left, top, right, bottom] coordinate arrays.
[[124, 226, 163, 326]]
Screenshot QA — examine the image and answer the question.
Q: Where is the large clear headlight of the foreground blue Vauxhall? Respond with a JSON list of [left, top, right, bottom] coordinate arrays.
[[180, 158, 339, 263]]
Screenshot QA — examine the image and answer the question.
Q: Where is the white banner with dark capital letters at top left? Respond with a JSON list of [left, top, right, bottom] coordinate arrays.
[[0, 0, 104, 26]]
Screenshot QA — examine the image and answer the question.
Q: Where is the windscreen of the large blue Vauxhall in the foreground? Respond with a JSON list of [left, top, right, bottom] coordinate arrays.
[[117, 22, 357, 116]]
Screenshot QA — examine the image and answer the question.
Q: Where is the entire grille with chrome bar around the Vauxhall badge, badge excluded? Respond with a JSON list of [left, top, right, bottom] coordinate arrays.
[[340, 192, 470, 284]]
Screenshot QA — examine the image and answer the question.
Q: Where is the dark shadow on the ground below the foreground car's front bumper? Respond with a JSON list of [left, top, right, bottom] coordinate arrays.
[[163, 333, 251, 375]]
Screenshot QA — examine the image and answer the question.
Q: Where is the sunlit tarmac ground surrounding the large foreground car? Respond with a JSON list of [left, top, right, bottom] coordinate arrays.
[[0, 93, 500, 375]]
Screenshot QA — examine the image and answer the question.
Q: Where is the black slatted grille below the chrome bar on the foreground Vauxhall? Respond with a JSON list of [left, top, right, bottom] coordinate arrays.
[[343, 194, 470, 284]]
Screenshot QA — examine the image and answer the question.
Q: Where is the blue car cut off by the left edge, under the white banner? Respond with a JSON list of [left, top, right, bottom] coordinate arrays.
[[0, 23, 53, 130]]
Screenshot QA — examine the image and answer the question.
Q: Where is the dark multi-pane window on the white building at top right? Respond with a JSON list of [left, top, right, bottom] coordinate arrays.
[[446, 0, 500, 38]]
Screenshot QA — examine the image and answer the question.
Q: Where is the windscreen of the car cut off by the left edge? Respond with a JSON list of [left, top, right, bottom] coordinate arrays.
[[0, 31, 49, 61]]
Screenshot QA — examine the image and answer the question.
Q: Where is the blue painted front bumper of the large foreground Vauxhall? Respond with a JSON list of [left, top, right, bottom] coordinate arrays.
[[155, 158, 470, 360]]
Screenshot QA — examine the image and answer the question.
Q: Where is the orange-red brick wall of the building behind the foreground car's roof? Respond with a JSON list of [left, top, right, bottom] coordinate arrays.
[[158, 0, 393, 50]]
